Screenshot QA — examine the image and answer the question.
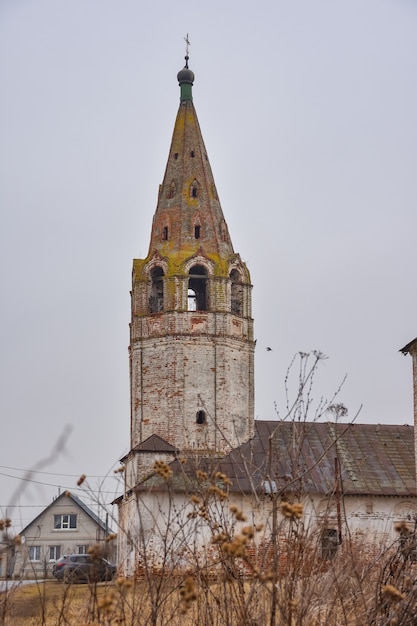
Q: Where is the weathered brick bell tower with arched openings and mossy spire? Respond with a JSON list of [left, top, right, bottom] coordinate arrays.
[[128, 55, 255, 470]]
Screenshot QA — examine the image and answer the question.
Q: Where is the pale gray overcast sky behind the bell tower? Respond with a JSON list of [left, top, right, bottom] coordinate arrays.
[[0, 0, 417, 530]]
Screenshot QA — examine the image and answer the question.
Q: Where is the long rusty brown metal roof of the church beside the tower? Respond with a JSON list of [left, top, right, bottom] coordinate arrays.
[[138, 420, 417, 497]]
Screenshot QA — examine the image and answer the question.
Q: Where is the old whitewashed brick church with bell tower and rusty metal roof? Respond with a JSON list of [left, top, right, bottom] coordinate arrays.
[[116, 54, 417, 576]]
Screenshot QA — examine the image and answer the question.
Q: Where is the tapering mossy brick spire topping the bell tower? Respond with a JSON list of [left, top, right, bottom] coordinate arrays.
[[145, 54, 233, 261]]
